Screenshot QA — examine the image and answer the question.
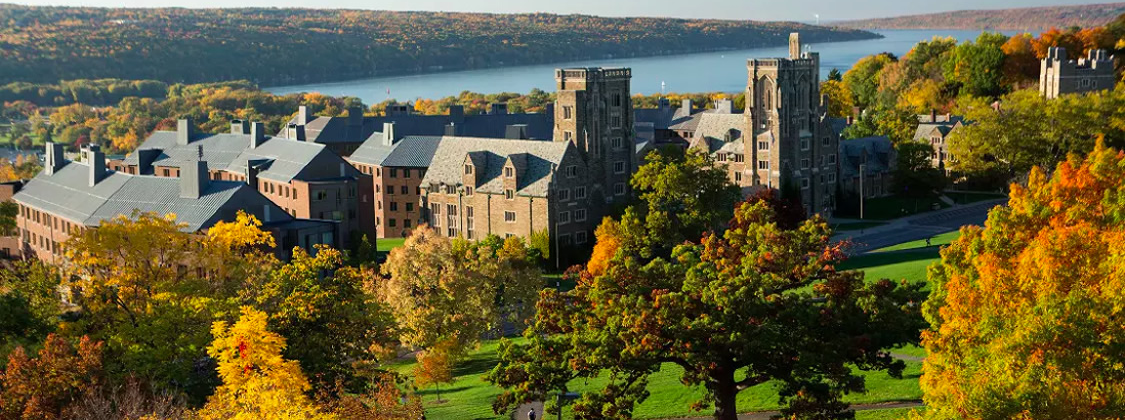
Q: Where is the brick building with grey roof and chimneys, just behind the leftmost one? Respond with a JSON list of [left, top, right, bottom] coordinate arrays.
[[110, 119, 375, 243]]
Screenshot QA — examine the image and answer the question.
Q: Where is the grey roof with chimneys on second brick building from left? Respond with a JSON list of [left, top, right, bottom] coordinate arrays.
[[123, 132, 346, 182]]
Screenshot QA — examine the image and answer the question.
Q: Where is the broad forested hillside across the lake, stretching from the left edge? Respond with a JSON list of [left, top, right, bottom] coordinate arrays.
[[0, 5, 878, 86]]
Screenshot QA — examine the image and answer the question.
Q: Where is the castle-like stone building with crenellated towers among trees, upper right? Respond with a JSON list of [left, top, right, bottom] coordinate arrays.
[[1040, 46, 1117, 99]]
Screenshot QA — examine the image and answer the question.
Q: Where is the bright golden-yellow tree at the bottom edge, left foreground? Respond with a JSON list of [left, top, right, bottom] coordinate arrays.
[[199, 307, 334, 419]]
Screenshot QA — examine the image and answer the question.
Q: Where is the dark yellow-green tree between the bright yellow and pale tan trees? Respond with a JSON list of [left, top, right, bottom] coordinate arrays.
[[252, 245, 397, 391]]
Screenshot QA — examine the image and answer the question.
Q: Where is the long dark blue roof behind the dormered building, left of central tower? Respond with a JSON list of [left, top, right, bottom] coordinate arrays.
[[278, 114, 555, 144]]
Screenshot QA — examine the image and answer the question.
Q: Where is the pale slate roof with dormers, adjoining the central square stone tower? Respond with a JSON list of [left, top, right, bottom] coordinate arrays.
[[418, 136, 573, 197]]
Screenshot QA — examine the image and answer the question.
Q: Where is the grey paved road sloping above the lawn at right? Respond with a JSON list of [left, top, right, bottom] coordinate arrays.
[[833, 198, 1007, 254]]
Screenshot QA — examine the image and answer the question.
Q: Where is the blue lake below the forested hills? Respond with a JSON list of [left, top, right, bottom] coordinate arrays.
[[266, 30, 1013, 105]]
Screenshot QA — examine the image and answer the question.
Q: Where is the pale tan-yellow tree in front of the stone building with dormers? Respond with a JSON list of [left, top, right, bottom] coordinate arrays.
[[375, 227, 542, 348]]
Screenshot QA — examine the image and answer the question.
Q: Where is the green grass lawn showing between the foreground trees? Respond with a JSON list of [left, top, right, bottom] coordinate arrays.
[[391, 244, 952, 419]]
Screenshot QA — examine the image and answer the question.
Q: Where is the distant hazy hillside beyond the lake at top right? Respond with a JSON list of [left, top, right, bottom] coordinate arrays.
[[836, 3, 1125, 32]]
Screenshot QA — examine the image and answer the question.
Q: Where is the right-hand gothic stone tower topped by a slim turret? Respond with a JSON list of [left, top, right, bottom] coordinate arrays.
[[743, 34, 838, 215]]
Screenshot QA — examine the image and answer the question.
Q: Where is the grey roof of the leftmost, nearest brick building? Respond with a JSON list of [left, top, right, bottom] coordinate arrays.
[[12, 158, 285, 232]]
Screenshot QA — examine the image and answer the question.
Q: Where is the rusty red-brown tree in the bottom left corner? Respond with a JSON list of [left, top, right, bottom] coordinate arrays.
[[0, 334, 105, 419]]
